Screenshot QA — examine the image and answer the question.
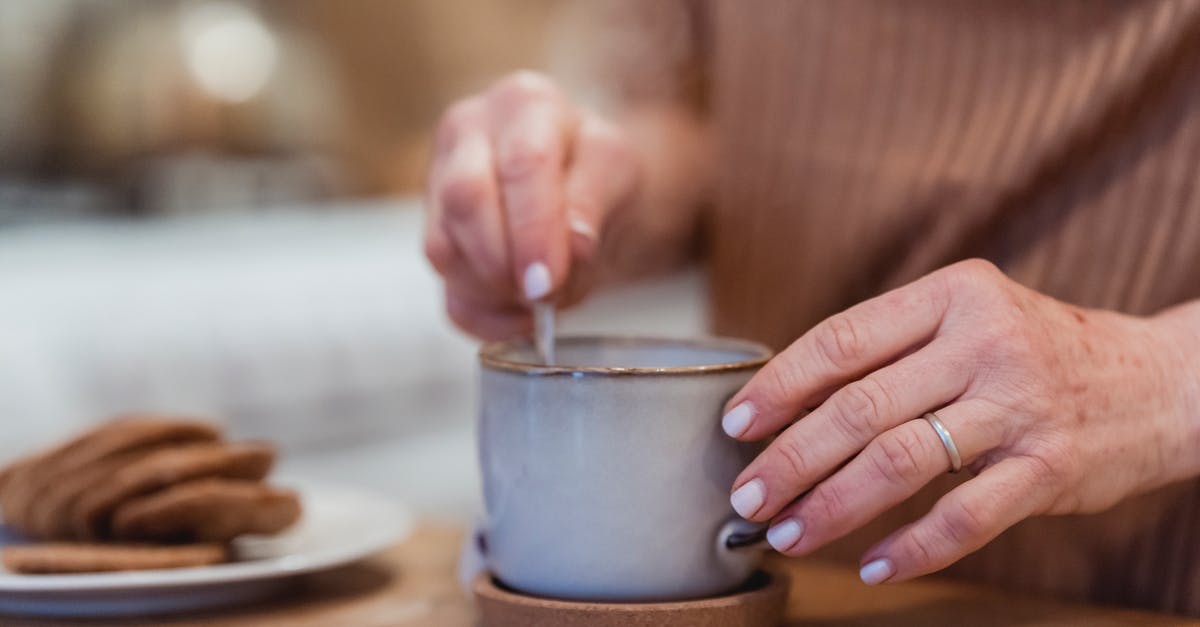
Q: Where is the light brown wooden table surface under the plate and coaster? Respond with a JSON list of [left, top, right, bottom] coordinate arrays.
[[0, 526, 1200, 627]]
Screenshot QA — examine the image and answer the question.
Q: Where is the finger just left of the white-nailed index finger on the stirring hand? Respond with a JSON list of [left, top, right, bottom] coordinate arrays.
[[432, 125, 516, 292]]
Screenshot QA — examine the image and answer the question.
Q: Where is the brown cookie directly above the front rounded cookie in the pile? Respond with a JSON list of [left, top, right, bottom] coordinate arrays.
[[70, 442, 275, 539]]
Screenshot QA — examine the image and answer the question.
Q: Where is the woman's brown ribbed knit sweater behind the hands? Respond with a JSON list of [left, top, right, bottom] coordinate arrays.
[[566, 0, 1200, 615]]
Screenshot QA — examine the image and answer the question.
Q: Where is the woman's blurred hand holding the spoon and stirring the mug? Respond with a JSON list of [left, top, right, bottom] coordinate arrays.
[[425, 72, 637, 339]]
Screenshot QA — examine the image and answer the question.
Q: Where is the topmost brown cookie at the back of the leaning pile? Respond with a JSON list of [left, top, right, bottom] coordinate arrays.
[[0, 416, 221, 531]]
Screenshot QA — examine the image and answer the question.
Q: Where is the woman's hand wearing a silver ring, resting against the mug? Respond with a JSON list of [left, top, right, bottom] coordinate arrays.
[[722, 255, 1200, 584]]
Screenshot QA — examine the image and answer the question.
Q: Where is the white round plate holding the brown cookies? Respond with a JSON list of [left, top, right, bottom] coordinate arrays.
[[0, 479, 413, 616]]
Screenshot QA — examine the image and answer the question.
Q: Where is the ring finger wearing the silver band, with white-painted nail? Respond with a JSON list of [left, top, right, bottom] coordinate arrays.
[[767, 399, 1003, 555]]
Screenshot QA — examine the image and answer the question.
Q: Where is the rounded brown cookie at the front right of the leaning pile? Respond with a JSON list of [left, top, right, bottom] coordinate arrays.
[[113, 479, 300, 542]]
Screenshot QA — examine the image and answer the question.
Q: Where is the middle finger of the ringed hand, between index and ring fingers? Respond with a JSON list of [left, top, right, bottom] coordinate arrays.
[[731, 340, 970, 521]]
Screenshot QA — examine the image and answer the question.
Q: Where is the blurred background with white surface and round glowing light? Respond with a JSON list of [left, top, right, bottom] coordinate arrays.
[[0, 0, 704, 518]]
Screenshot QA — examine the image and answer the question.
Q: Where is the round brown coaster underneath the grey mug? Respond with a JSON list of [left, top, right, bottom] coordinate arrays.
[[472, 572, 787, 627]]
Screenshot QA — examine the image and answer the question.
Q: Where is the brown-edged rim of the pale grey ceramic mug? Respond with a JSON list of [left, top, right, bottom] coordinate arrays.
[[479, 335, 775, 376]]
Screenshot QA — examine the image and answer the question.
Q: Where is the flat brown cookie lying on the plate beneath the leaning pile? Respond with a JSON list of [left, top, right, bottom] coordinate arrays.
[[0, 542, 229, 574]]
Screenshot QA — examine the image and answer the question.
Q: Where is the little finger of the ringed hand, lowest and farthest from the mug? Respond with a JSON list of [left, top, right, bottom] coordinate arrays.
[[860, 458, 1049, 584]]
